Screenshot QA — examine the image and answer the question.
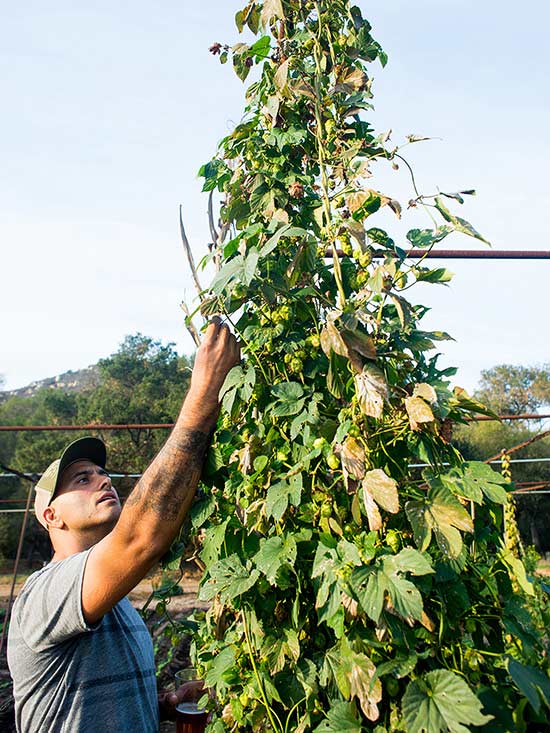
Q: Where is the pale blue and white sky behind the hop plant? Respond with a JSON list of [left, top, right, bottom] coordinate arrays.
[[0, 0, 550, 390]]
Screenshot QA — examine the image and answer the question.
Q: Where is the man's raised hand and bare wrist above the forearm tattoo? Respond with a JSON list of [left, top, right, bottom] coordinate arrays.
[[182, 317, 241, 429]]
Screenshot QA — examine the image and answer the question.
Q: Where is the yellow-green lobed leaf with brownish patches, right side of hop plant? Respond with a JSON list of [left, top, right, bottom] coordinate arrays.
[[405, 482, 474, 559]]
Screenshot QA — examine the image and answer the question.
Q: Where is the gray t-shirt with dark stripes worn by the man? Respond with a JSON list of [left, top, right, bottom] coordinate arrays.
[[8, 550, 159, 733]]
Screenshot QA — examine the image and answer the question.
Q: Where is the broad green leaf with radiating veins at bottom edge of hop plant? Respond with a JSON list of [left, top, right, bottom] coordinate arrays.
[[402, 669, 493, 733]]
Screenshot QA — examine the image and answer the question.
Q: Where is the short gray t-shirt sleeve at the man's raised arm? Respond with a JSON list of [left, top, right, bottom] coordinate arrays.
[[14, 550, 101, 651]]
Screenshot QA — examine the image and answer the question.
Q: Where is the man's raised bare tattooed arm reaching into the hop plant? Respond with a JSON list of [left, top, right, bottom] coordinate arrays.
[[82, 319, 240, 623]]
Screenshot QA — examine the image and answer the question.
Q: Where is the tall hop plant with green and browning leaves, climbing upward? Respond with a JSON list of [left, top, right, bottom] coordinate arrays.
[[177, 0, 550, 733]]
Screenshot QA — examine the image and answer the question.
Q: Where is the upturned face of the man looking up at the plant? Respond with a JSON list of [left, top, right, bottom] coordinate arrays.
[[51, 460, 121, 533]]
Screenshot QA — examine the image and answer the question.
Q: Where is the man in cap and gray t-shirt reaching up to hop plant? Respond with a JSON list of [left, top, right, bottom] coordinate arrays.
[[8, 319, 239, 733]]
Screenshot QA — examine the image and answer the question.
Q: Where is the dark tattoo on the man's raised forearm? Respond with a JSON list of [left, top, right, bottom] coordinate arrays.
[[126, 429, 211, 522]]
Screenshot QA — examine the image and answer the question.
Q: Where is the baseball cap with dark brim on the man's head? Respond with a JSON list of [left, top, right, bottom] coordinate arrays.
[[34, 437, 107, 529]]
